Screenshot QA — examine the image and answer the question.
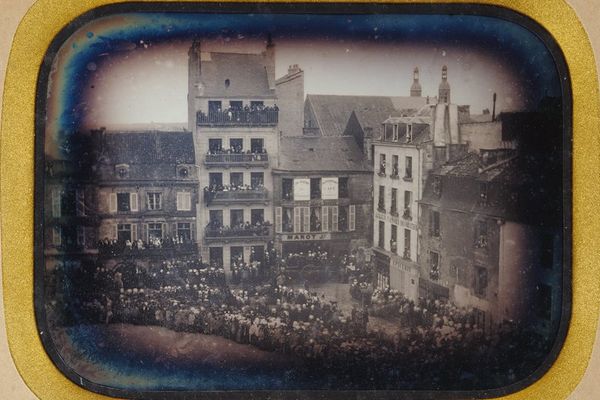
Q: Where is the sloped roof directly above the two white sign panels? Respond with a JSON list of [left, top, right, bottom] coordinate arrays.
[[277, 136, 372, 172]]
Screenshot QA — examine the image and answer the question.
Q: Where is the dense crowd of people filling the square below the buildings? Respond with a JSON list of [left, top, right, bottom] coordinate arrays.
[[47, 251, 547, 389]]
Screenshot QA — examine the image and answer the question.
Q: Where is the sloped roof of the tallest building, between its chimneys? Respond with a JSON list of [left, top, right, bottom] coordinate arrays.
[[200, 52, 275, 98]]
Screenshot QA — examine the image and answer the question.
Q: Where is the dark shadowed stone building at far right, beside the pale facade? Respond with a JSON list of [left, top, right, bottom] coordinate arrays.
[[420, 149, 562, 329]]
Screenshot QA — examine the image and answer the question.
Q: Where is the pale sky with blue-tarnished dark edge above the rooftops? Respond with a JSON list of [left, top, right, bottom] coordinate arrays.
[[47, 13, 560, 138]]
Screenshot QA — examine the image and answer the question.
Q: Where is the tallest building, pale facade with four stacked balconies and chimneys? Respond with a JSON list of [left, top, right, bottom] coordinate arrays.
[[188, 40, 279, 269]]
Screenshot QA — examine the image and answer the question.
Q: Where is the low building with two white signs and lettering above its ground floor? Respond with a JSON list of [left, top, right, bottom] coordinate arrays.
[[273, 136, 372, 254]]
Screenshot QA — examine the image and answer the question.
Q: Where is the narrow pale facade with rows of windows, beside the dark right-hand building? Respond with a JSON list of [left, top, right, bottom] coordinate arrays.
[[373, 111, 433, 299]]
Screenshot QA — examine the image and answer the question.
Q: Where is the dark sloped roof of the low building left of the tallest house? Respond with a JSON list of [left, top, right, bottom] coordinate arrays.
[[102, 132, 195, 164]]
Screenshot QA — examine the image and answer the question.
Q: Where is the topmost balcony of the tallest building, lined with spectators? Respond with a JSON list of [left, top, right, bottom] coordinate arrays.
[[196, 108, 279, 126]]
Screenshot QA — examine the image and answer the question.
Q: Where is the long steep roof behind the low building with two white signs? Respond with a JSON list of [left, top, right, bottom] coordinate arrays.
[[306, 94, 426, 136]]
